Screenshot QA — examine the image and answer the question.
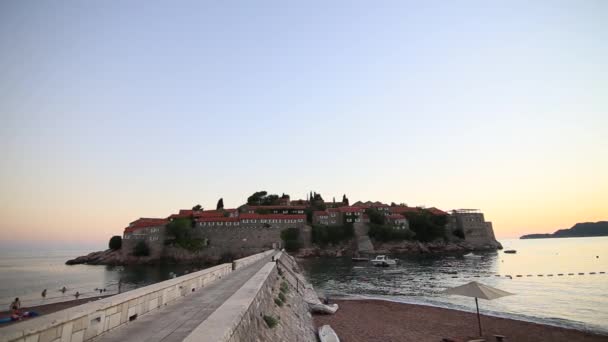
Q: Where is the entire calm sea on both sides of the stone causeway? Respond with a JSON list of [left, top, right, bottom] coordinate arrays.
[[0, 237, 608, 334]]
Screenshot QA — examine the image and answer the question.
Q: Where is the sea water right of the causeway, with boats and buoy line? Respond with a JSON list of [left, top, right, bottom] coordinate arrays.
[[303, 237, 608, 334]]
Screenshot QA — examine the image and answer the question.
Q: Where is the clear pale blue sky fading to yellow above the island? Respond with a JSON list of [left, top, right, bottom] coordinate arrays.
[[0, 0, 608, 244]]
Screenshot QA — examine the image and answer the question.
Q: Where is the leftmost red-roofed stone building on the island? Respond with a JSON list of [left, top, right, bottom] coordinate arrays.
[[121, 217, 169, 257]]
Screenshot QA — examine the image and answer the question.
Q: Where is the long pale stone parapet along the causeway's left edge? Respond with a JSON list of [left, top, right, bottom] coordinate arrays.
[[0, 264, 233, 342]]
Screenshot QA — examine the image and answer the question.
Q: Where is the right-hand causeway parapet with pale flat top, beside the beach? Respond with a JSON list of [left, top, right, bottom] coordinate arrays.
[[183, 262, 277, 342]]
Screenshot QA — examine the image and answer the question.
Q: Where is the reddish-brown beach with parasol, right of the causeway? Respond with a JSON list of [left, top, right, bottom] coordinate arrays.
[[313, 300, 608, 342]]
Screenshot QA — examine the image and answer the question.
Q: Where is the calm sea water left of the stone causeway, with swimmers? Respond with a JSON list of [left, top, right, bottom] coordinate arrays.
[[0, 249, 202, 311]]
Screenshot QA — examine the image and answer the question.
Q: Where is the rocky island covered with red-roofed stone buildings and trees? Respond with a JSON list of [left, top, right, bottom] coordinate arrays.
[[66, 191, 502, 265]]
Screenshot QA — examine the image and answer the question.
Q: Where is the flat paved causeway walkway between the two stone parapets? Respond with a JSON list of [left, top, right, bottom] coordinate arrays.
[[94, 257, 271, 342]]
